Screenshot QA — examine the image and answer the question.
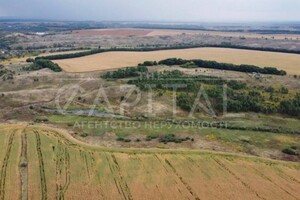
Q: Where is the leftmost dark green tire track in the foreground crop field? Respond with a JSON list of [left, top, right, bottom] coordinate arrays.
[[0, 131, 16, 199]]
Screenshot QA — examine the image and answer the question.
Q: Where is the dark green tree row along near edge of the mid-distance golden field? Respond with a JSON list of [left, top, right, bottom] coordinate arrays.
[[139, 58, 287, 76]]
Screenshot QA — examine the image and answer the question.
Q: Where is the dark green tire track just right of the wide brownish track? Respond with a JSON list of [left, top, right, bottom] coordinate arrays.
[[34, 131, 48, 200]]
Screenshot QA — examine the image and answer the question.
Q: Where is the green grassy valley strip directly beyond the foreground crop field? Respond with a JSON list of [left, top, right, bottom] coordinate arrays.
[[48, 115, 300, 160]]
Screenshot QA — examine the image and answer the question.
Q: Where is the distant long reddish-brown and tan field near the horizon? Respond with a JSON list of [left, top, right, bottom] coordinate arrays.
[[72, 28, 300, 40]]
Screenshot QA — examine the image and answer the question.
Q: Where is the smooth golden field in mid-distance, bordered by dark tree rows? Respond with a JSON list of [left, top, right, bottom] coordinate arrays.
[[55, 48, 300, 74]]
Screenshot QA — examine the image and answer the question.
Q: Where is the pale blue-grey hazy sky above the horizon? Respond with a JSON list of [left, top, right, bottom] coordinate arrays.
[[0, 0, 300, 22]]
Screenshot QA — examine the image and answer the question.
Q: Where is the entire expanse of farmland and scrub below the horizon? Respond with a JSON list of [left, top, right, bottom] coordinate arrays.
[[0, 21, 300, 200]]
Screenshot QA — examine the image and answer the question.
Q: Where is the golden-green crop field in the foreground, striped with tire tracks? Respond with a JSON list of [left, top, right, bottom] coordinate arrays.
[[0, 125, 300, 199]]
